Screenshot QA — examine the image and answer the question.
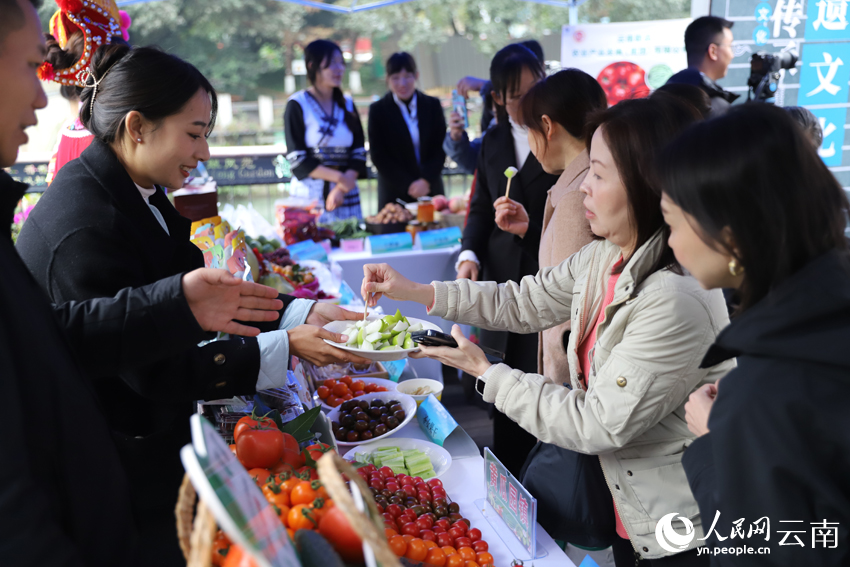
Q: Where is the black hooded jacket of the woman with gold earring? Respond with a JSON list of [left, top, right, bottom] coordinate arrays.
[[671, 251, 850, 567]]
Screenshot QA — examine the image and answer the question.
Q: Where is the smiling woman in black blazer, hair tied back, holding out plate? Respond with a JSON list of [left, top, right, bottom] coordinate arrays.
[[17, 46, 362, 565]]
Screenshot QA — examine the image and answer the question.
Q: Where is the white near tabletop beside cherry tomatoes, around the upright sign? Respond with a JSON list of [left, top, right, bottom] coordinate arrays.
[[386, 419, 575, 567]]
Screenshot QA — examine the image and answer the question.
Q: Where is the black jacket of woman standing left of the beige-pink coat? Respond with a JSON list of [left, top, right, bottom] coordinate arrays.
[[463, 120, 558, 372]]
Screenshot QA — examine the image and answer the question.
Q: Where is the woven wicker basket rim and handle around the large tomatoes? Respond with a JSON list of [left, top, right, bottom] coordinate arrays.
[[174, 458, 401, 567]]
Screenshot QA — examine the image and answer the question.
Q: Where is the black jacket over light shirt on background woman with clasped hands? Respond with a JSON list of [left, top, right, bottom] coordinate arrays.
[[368, 91, 446, 209]]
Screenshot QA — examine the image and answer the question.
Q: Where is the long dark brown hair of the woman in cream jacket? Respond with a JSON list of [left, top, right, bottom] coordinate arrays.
[[584, 96, 702, 282]]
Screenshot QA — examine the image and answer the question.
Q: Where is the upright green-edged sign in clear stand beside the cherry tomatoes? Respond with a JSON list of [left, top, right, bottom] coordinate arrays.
[[484, 447, 537, 557]]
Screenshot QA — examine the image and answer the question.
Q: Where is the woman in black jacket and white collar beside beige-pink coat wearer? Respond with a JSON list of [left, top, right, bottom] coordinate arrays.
[[457, 44, 558, 478]]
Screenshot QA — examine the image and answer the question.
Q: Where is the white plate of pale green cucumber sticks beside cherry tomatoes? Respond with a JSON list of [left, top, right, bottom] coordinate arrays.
[[343, 437, 452, 480]]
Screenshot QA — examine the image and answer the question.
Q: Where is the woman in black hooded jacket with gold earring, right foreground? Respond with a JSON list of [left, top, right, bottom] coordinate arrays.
[[661, 104, 850, 565]]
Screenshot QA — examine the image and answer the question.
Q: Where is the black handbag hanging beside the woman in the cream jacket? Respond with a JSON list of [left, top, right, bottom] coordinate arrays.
[[521, 441, 617, 548]]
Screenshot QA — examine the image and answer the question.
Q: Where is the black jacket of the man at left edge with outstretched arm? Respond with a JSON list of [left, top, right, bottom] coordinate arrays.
[[0, 172, 206, 567]]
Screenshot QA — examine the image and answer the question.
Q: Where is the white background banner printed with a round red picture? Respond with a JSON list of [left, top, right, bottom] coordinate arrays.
[[561, 19, 691, 104]]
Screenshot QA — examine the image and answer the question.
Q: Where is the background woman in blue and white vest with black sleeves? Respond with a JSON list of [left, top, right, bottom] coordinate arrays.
[[283, 39, 366, 223]]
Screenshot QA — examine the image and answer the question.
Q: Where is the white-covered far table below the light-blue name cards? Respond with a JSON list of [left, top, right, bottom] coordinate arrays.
[[329, 245, 460, 382]]
